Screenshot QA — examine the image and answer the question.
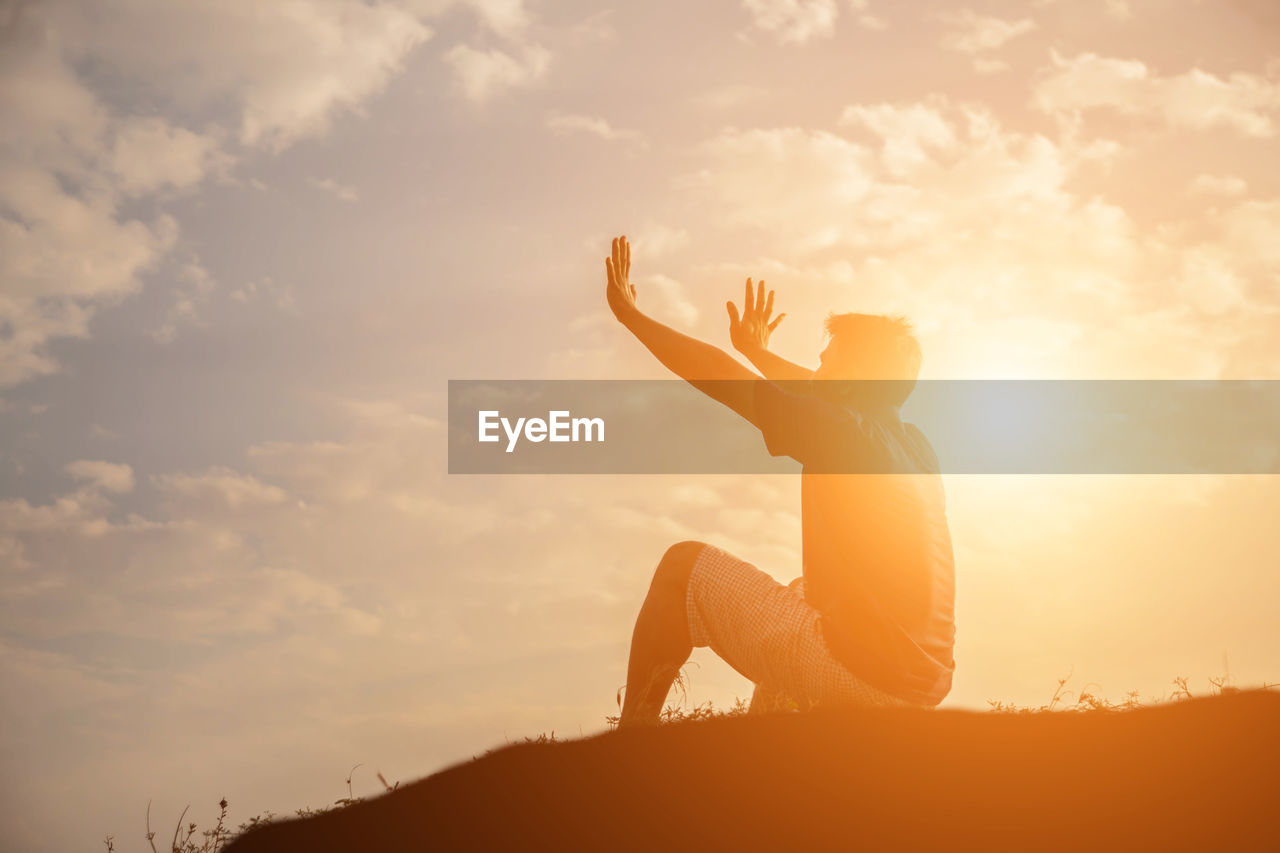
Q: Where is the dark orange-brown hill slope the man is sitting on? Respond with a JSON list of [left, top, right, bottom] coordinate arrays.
[[228, 690, 1280, 853]]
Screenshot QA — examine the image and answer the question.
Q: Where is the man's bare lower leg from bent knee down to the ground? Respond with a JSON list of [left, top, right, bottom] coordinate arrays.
[[618, 542, 707, 726]]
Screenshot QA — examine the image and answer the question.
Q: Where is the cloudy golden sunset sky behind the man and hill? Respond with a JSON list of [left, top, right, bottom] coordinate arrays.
[[0, 0, 1280, 852]]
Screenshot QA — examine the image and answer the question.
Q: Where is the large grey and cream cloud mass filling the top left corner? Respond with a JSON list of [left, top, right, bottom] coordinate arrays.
[[0, 0, 435, 387]]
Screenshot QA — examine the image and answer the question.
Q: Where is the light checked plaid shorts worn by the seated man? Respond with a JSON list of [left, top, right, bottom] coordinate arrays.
[[685, 546, 924, 712]]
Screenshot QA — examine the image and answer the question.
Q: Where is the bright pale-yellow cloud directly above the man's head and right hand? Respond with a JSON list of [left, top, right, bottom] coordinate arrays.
[[689, 97, 1071, 257]]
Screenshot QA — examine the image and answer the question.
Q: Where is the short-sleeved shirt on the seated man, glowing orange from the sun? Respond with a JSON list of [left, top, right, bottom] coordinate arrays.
[[754, 382, 955, 706]]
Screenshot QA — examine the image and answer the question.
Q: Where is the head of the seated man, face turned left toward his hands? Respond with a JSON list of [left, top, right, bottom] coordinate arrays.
[[813, 314, 920, 406]]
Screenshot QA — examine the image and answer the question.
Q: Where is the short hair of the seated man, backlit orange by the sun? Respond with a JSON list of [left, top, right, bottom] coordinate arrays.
[[826, 314, 922, 406]]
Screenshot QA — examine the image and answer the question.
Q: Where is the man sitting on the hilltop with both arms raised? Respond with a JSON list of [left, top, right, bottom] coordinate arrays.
[[605, 237, 955, 726]]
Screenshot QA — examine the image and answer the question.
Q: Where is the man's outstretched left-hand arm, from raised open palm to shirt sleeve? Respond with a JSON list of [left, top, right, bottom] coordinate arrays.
[[604, 237, 759, 420]]
